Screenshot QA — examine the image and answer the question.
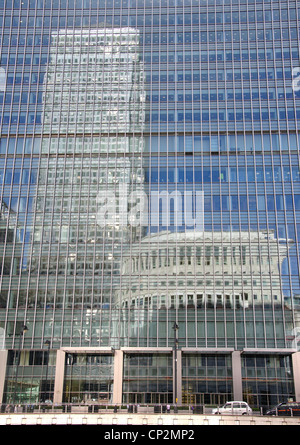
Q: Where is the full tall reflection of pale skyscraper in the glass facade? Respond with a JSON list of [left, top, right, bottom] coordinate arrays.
[[33, 28, 144, 320]]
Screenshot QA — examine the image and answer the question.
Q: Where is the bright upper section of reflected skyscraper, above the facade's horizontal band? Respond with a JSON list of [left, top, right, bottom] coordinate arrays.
[[43, 28, 144, 134]]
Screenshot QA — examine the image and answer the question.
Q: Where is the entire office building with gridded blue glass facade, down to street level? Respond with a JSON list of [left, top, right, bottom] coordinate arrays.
[[0, 0, 300, 406]]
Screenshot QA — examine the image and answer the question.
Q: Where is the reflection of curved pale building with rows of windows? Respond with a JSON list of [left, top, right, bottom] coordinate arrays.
[[117, 232, 288, 309]]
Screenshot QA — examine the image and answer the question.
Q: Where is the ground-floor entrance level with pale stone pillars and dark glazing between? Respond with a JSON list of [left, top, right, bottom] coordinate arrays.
[[0, 348, 300, 408]]
